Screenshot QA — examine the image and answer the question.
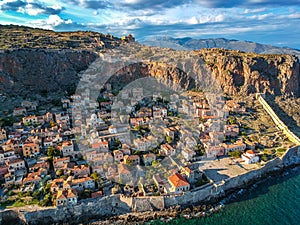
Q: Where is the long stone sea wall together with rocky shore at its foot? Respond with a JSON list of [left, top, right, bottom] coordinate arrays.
[[0, 147, 300, 225]]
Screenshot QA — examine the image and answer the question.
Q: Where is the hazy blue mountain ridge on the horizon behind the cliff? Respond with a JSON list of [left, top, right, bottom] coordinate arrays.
[[140, 37, 300, 57]]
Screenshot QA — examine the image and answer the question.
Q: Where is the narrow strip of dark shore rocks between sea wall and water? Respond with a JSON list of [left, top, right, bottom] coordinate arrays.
[[85, 164, 300, 225]]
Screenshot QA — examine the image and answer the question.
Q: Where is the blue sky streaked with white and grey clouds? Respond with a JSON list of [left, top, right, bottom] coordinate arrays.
[[0, 0, 300, 49]]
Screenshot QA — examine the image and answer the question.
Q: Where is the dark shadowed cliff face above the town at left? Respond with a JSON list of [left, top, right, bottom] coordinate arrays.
[[0, 49, 97, 96]]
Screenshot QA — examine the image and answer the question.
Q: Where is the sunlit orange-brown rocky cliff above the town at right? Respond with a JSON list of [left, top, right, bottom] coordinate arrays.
[[104, 46, 300, 95]]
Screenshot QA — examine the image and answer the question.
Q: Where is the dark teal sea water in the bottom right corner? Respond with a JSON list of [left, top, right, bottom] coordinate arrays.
[[150, 167, 300, 225]]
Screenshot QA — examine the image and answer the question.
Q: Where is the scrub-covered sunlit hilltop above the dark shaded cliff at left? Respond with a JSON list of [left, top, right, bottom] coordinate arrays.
[[0, 25, 121, 50]]
